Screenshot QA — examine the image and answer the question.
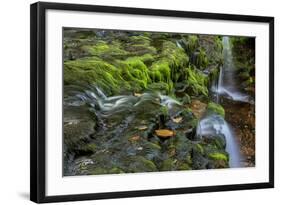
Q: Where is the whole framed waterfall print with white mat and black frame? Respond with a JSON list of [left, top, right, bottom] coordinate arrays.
[[30, 2, 274, 203]]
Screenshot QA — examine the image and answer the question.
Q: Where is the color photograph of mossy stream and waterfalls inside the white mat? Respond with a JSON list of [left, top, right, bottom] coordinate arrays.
[[62, 27, 256, 176]]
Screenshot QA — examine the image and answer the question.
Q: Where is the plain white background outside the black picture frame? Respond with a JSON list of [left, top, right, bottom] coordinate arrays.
[[0, 0, 276, 205]]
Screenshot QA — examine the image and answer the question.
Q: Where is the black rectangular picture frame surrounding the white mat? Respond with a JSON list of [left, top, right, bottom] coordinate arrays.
[[30, 2, 274, 203]]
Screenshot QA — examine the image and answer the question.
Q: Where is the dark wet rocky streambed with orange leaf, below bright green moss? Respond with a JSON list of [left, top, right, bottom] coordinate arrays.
[[64, 85, 228, 175]]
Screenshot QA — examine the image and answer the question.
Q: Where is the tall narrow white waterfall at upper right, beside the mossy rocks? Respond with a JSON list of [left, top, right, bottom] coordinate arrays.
[[214, 36, 251, 102]]
